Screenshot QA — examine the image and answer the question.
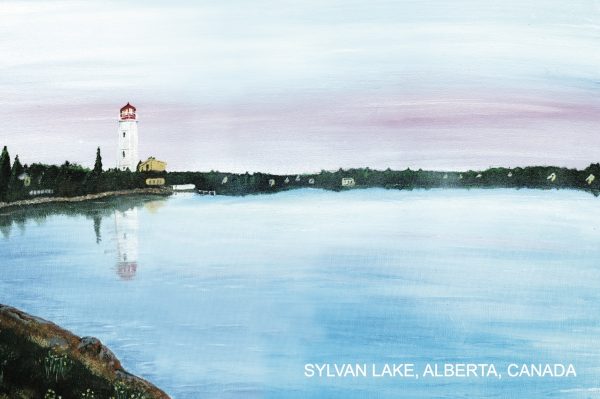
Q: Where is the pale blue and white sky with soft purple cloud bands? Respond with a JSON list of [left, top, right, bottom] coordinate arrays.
[[0, 0, 600, 173]]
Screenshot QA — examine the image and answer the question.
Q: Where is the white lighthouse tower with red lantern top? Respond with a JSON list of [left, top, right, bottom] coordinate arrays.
[[117, 103, 140, 172]]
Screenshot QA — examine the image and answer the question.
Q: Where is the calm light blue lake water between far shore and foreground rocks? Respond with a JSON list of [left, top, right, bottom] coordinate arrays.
[[0, 189, 600, 399]]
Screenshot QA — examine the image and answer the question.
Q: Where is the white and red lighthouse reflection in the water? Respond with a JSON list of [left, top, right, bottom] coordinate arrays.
[[115, 208, 139, 280]]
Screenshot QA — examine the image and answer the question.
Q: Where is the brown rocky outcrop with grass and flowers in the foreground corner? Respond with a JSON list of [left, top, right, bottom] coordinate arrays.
[[0, 305, 169, 399]]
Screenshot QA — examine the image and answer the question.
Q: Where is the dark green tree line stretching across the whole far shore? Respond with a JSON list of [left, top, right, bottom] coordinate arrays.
[[0, 142, 600, 202]]
